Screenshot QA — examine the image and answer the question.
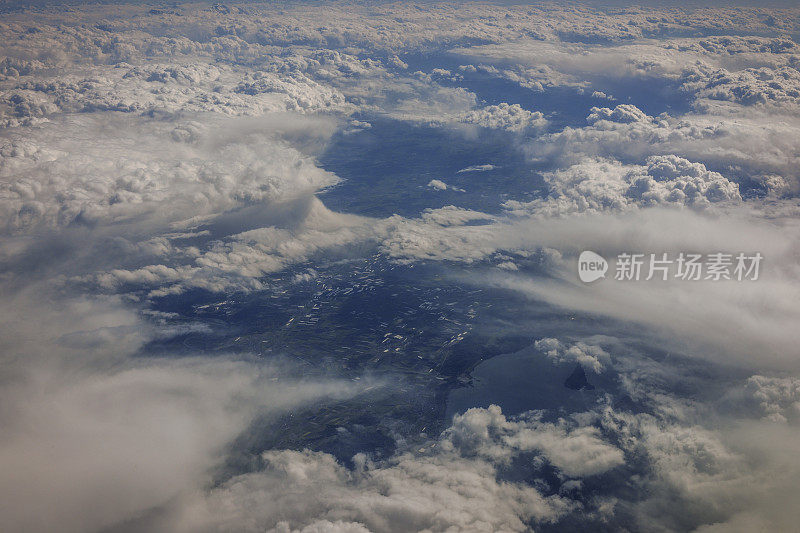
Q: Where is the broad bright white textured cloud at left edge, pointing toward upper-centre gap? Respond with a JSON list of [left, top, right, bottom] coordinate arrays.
[[0, 114, 337, 233]]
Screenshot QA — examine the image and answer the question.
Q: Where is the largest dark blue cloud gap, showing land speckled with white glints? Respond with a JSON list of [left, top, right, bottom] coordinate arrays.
[[142, 255, 592, 472]]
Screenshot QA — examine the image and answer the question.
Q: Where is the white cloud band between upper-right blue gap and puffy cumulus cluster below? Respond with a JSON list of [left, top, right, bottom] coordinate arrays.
[[526, 104, 798, 192]]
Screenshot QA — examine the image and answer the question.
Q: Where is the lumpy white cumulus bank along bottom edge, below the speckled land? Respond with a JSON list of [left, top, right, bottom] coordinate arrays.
[[133, 406, 622, 531]]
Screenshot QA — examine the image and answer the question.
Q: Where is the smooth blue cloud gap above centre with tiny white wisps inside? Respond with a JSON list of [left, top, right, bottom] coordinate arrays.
[[319, 116, 544, 217]]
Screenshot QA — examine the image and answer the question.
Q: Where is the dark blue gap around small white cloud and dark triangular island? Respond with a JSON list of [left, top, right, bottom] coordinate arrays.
[[445, 310, 749, 420]]
